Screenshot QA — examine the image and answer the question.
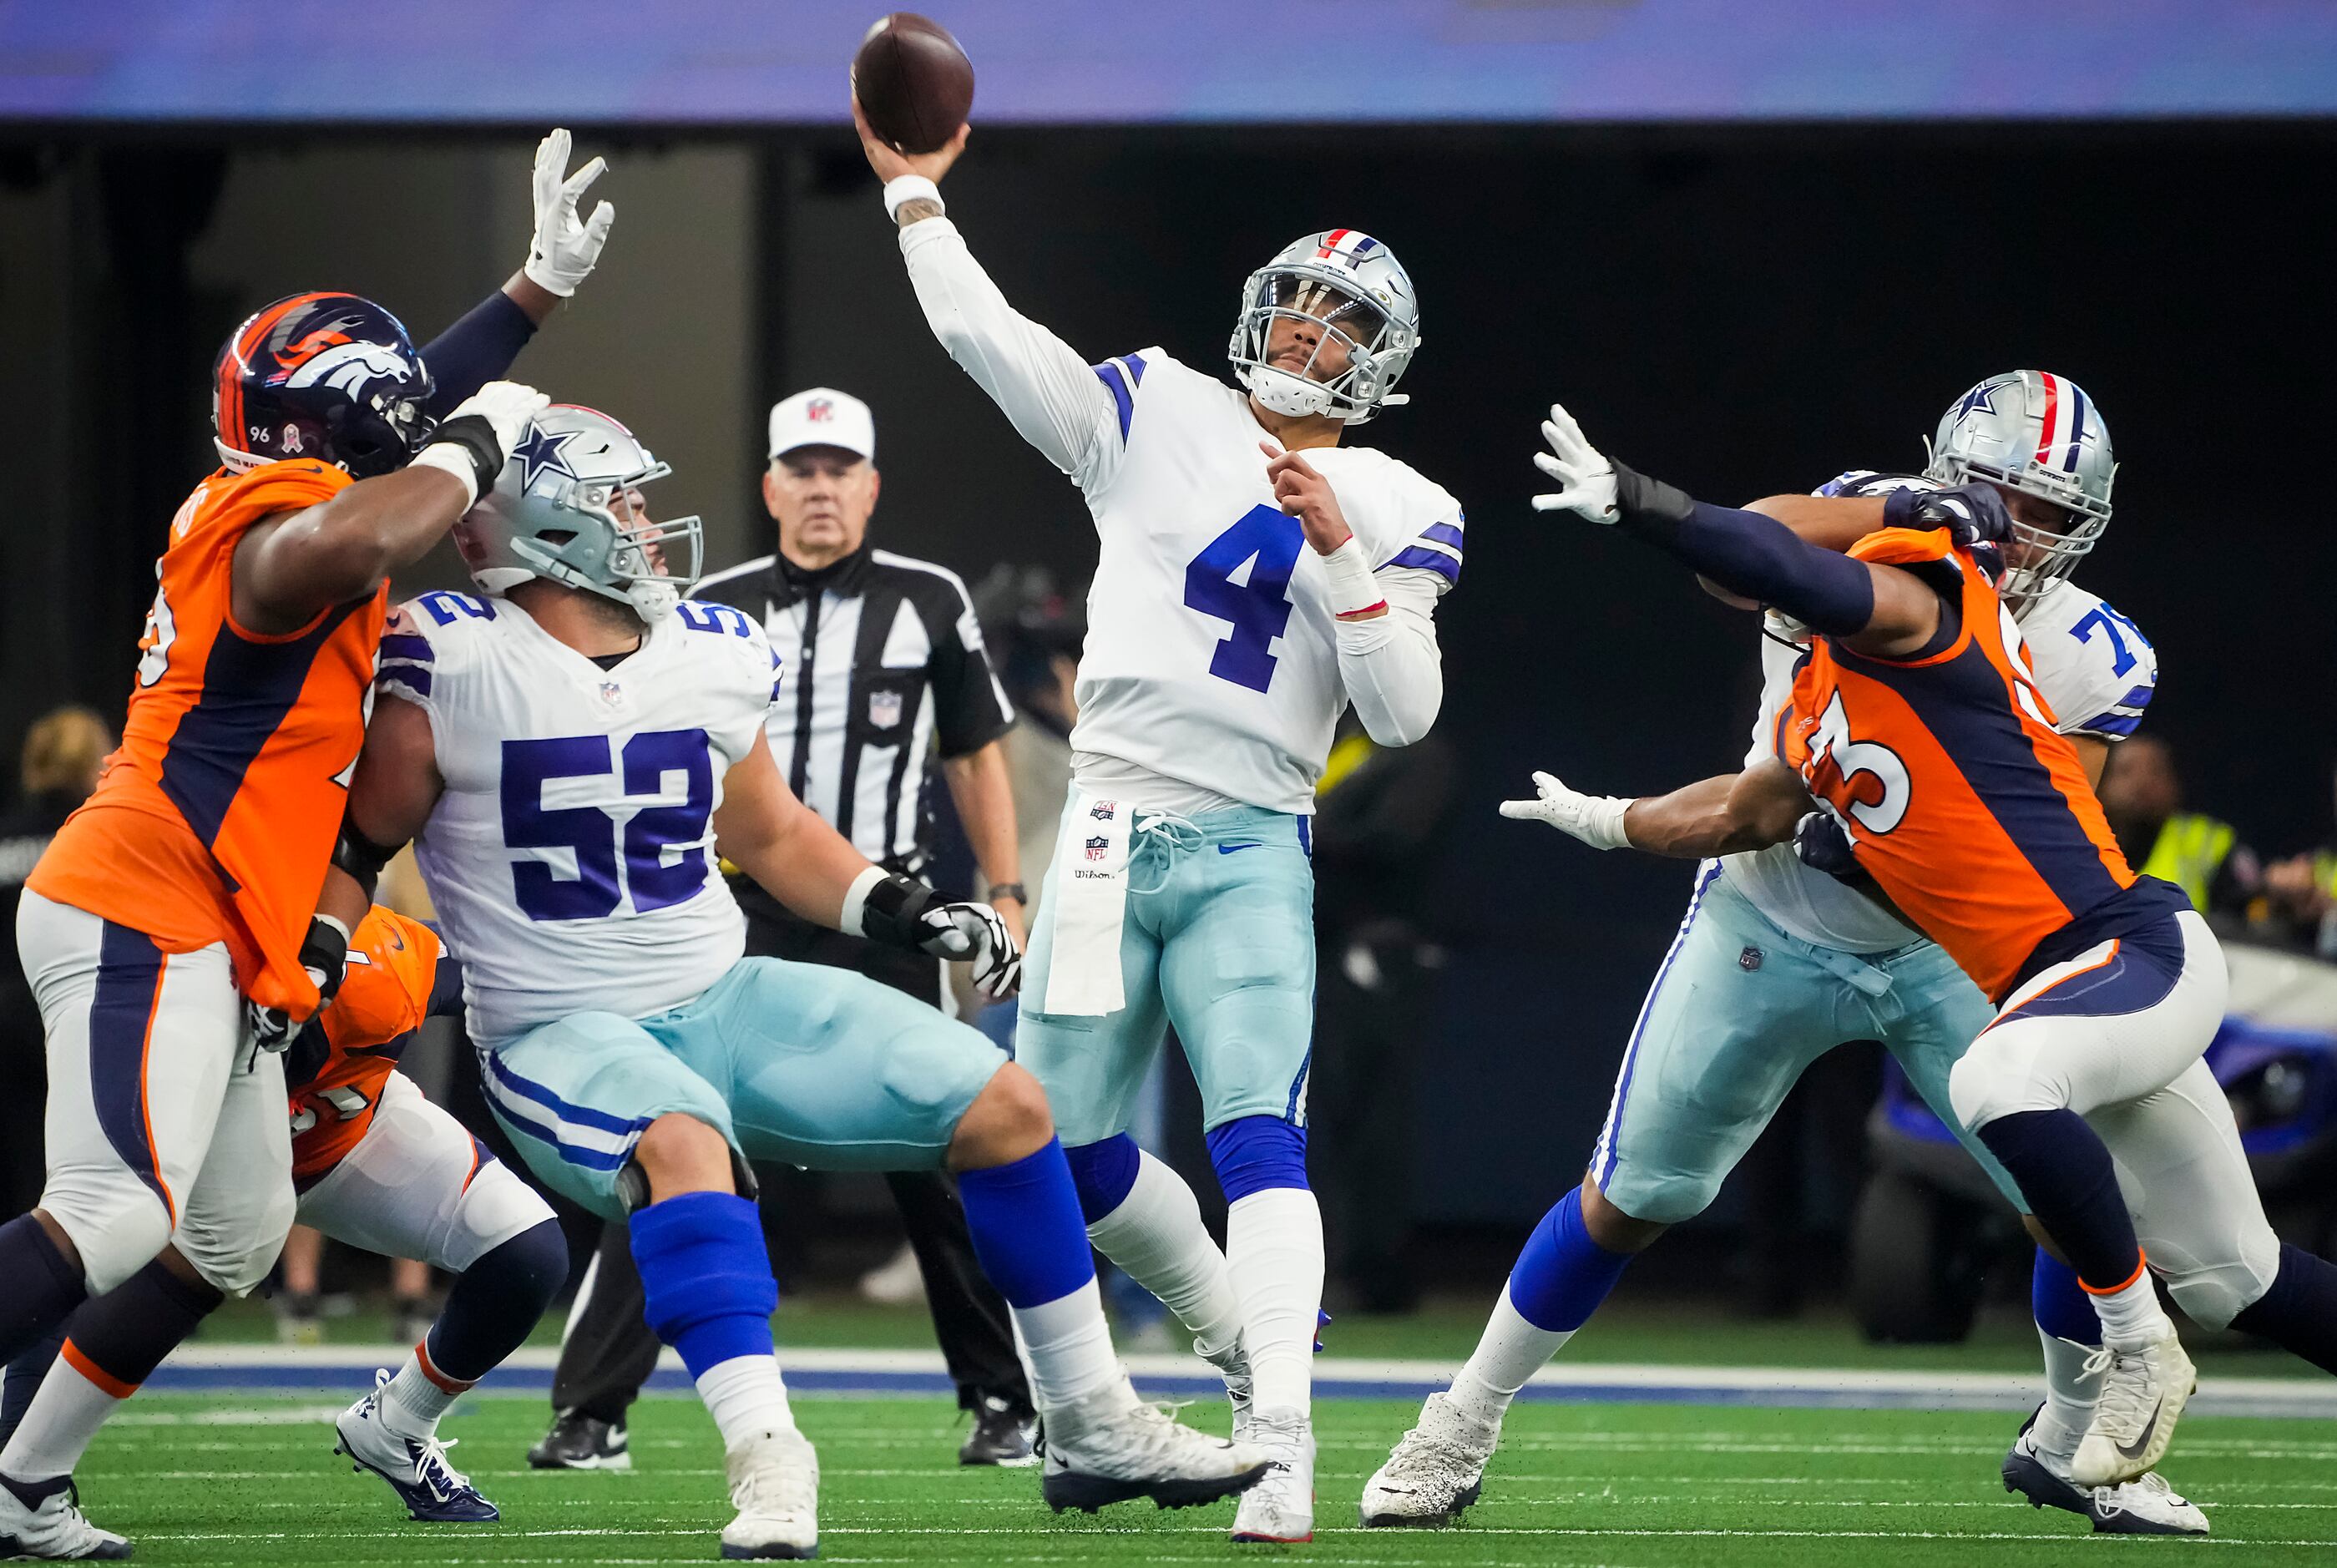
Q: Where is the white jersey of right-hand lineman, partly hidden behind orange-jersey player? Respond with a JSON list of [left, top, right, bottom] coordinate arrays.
[[1722, 472, 2159, 953]]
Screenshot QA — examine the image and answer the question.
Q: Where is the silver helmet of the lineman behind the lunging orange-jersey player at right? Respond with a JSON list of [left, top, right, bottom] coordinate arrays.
[[1924, 369, 2117, 615]]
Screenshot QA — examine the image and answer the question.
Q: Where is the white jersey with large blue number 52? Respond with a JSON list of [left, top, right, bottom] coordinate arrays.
[[378, 594, 776, 1047]]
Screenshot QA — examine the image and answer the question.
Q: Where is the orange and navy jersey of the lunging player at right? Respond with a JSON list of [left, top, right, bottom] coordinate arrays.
[[1781, 529, 2183, 998]]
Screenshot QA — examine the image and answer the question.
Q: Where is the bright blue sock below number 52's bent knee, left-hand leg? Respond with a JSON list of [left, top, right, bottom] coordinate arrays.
[[631, 1191, 778, 1376]]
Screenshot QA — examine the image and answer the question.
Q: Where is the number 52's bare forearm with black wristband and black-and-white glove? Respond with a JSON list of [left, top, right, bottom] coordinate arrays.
[[713, 734, 1021, 995]]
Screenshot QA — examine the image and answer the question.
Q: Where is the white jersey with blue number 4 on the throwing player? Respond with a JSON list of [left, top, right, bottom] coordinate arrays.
[[1070, 348, 1463, 813]]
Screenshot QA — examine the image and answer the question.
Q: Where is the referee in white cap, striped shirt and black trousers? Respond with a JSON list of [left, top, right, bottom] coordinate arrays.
[[529, 388, 1033, 1469]]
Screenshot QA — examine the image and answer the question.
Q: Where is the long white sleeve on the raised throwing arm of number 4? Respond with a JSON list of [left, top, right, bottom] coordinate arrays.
[[900, 217, 1126, 491]]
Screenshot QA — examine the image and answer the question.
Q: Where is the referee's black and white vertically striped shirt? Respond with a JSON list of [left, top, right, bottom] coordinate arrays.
[[692, 544, 1014, 872]]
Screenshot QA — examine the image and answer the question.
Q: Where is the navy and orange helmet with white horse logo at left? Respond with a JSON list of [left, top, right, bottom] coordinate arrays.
[[210, 295, 432, 479]]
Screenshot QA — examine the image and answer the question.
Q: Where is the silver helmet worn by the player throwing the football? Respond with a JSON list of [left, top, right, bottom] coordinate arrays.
[[1225, 229, 1421, 425]]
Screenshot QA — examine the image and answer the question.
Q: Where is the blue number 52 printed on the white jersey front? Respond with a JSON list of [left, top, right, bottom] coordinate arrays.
[[503, 729, 715, 921]]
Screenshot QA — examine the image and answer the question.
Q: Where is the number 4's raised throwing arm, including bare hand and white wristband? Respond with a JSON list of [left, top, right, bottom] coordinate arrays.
[[853, 99, 1120, 488]]
